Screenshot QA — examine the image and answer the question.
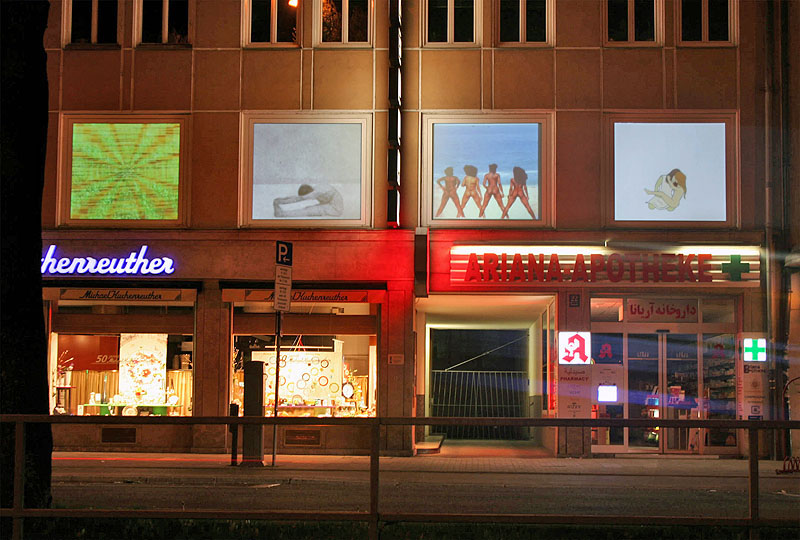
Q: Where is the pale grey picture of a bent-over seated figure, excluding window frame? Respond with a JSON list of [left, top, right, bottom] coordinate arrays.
[[252, 122, 364, 220]]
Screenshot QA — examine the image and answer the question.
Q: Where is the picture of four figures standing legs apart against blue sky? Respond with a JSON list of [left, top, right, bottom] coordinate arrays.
[[429, 122, 542, 222]]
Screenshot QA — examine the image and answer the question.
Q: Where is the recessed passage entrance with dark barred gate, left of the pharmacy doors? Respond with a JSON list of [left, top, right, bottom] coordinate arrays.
[[416, 294, 556, 447]]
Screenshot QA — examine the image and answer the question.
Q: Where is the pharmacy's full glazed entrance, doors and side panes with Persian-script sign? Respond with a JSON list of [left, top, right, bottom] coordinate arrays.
[[592, 297, 738, 454]]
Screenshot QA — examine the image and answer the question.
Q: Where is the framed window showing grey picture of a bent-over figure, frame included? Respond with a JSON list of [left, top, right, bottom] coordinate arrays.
[[241, 114, 372, 227]]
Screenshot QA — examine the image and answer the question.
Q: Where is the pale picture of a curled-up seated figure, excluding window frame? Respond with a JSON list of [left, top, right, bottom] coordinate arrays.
[[614, 122, 727, 222]]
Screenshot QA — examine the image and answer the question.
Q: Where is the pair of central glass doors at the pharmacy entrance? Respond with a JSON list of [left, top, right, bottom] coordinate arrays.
[[627, 331, 699, 452]]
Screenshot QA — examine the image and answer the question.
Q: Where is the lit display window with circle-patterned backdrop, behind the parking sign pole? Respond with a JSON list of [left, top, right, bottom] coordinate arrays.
[[231, 335, 377, 417]]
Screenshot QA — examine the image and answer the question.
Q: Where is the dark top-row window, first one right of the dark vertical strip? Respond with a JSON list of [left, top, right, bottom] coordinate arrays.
[[425, 0, 480, 44]]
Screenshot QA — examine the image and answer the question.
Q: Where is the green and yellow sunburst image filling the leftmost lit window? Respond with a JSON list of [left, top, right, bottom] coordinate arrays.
[[70, 123, 181, 219]]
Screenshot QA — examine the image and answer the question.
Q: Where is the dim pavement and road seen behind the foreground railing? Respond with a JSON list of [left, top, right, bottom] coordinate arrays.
[[53, 444, 800, 525]]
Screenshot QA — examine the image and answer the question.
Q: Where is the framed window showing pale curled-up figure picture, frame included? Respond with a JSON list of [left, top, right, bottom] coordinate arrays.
[[606, 112, 737, 230]]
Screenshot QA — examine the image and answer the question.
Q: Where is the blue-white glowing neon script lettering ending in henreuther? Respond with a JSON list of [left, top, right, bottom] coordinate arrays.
[[42, 245, 175, 275]]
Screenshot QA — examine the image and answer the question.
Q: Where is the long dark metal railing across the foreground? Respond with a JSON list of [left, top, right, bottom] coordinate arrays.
[[0, 415, 800, 540]]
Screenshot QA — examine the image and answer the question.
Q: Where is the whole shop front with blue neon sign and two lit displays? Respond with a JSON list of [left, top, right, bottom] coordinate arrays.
[[42, 231, 413, 454]]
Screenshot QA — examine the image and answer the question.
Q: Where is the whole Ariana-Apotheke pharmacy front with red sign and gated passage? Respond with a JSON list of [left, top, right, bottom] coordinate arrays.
[[417, 240, 769, 455]]
